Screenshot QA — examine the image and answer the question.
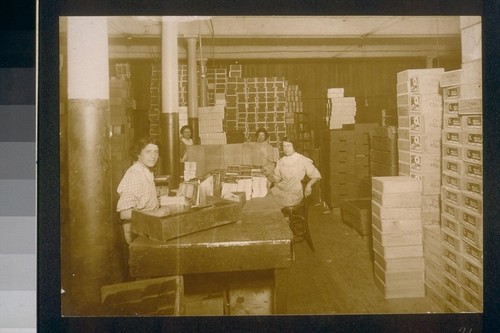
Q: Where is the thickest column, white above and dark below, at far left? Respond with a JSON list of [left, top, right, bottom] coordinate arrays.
[[63, 17, 122, 315]]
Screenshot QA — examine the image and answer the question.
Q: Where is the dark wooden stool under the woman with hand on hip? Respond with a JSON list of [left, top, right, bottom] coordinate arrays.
[[281, 197, 316, 252]]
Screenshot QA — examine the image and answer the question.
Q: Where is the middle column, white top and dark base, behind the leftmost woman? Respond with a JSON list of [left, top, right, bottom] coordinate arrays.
[[160, 16, 180, 188]]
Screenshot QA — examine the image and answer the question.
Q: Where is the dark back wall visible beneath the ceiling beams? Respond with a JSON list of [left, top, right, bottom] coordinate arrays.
[[110, 56, 460, 146]]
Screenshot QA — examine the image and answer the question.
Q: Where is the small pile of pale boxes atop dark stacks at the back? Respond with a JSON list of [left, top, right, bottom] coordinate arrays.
[[326, 88, 356, 129]]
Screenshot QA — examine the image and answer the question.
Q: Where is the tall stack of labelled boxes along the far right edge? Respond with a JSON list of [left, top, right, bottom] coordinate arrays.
[[441, 17, 483, 312]]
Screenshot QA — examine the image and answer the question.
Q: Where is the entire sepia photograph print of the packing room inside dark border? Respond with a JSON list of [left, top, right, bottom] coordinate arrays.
[[58, 15, 484, 317]]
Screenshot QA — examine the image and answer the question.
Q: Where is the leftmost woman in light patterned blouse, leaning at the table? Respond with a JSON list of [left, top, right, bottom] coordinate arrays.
[[116, 137, 170, 244]]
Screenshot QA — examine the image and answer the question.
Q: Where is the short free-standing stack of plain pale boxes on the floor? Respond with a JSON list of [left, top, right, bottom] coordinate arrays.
[[372, 176, 425, 298]]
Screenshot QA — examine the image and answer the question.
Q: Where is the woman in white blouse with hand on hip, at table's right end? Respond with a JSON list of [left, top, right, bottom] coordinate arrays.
[[268, 137, 321, 207]]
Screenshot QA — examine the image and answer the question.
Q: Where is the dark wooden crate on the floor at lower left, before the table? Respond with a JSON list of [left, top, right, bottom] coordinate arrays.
[[101, 276, 184, 316]]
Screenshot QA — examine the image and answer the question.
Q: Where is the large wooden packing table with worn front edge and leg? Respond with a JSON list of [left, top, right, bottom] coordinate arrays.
[[129, 194, 294, 313]]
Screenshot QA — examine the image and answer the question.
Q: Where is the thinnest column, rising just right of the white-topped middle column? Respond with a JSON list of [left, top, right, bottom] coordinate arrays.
[[186, 37, 199, 143]]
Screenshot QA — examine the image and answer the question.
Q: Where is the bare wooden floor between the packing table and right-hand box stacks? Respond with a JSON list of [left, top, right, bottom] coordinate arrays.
[[287, 205, 440, 314]]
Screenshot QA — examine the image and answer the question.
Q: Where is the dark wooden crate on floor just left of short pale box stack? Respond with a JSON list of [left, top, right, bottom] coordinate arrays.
[[341, 198, 372, 236]]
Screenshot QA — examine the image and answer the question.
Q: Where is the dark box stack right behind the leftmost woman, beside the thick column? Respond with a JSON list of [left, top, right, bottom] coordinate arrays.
[[109, 77, 134, 200]]
